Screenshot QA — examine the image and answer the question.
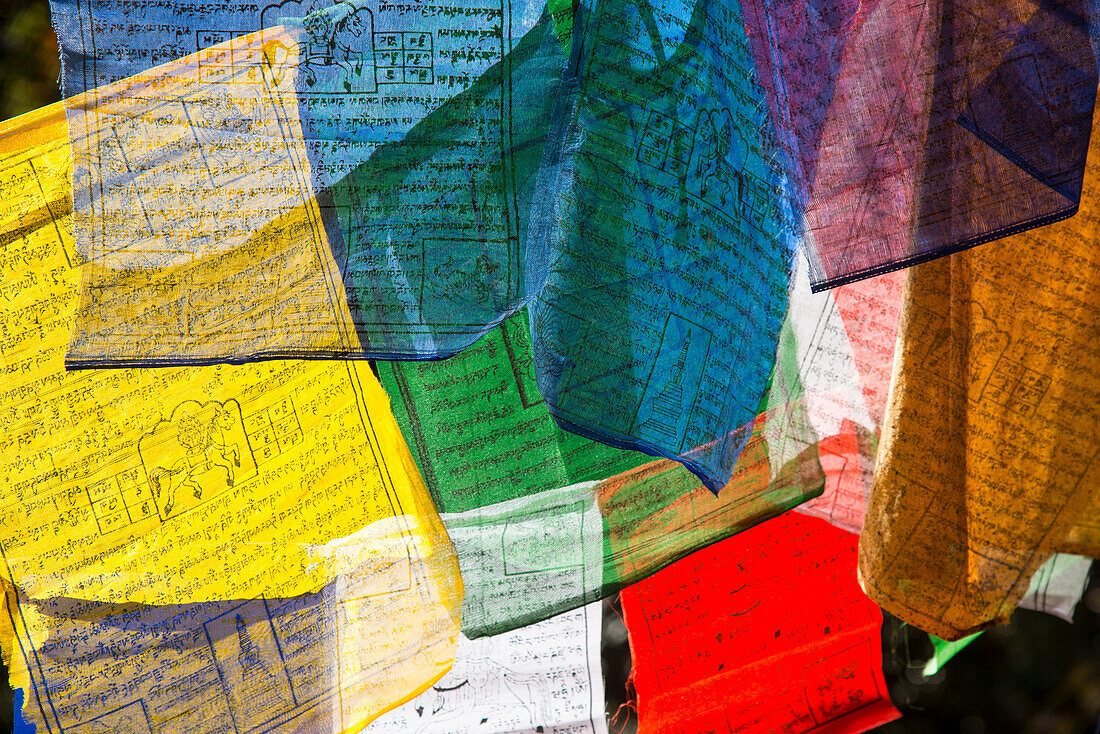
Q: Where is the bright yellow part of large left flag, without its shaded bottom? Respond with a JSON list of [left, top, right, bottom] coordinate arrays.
[[0, 105, 462, 624]]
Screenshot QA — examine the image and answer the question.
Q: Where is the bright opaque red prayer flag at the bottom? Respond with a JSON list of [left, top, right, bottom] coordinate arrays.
[[622, 513, 901, 734]]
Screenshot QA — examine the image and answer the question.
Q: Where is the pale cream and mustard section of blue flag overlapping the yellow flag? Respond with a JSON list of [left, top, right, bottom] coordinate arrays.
[[64, 26, 361, 368]]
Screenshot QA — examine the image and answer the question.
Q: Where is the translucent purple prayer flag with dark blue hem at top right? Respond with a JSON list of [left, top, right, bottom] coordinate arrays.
[[745, 0, 1100, 288]]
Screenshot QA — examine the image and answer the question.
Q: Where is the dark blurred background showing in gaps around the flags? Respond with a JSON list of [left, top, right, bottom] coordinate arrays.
[[0, 0, 1100, 734]]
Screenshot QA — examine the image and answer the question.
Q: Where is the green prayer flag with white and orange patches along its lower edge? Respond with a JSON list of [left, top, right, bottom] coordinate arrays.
[[377, 303, 824, 637]]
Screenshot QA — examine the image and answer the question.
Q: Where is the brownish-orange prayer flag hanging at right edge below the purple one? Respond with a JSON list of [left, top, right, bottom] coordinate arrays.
[[860, 99, 1100, 639]]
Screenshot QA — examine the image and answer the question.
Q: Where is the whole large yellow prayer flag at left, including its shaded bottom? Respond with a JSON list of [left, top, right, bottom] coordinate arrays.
[[0, 105, 462, 733]]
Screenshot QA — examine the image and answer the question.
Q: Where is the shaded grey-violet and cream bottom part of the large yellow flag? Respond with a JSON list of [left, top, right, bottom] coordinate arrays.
[[0, 518, 459, 734]]
